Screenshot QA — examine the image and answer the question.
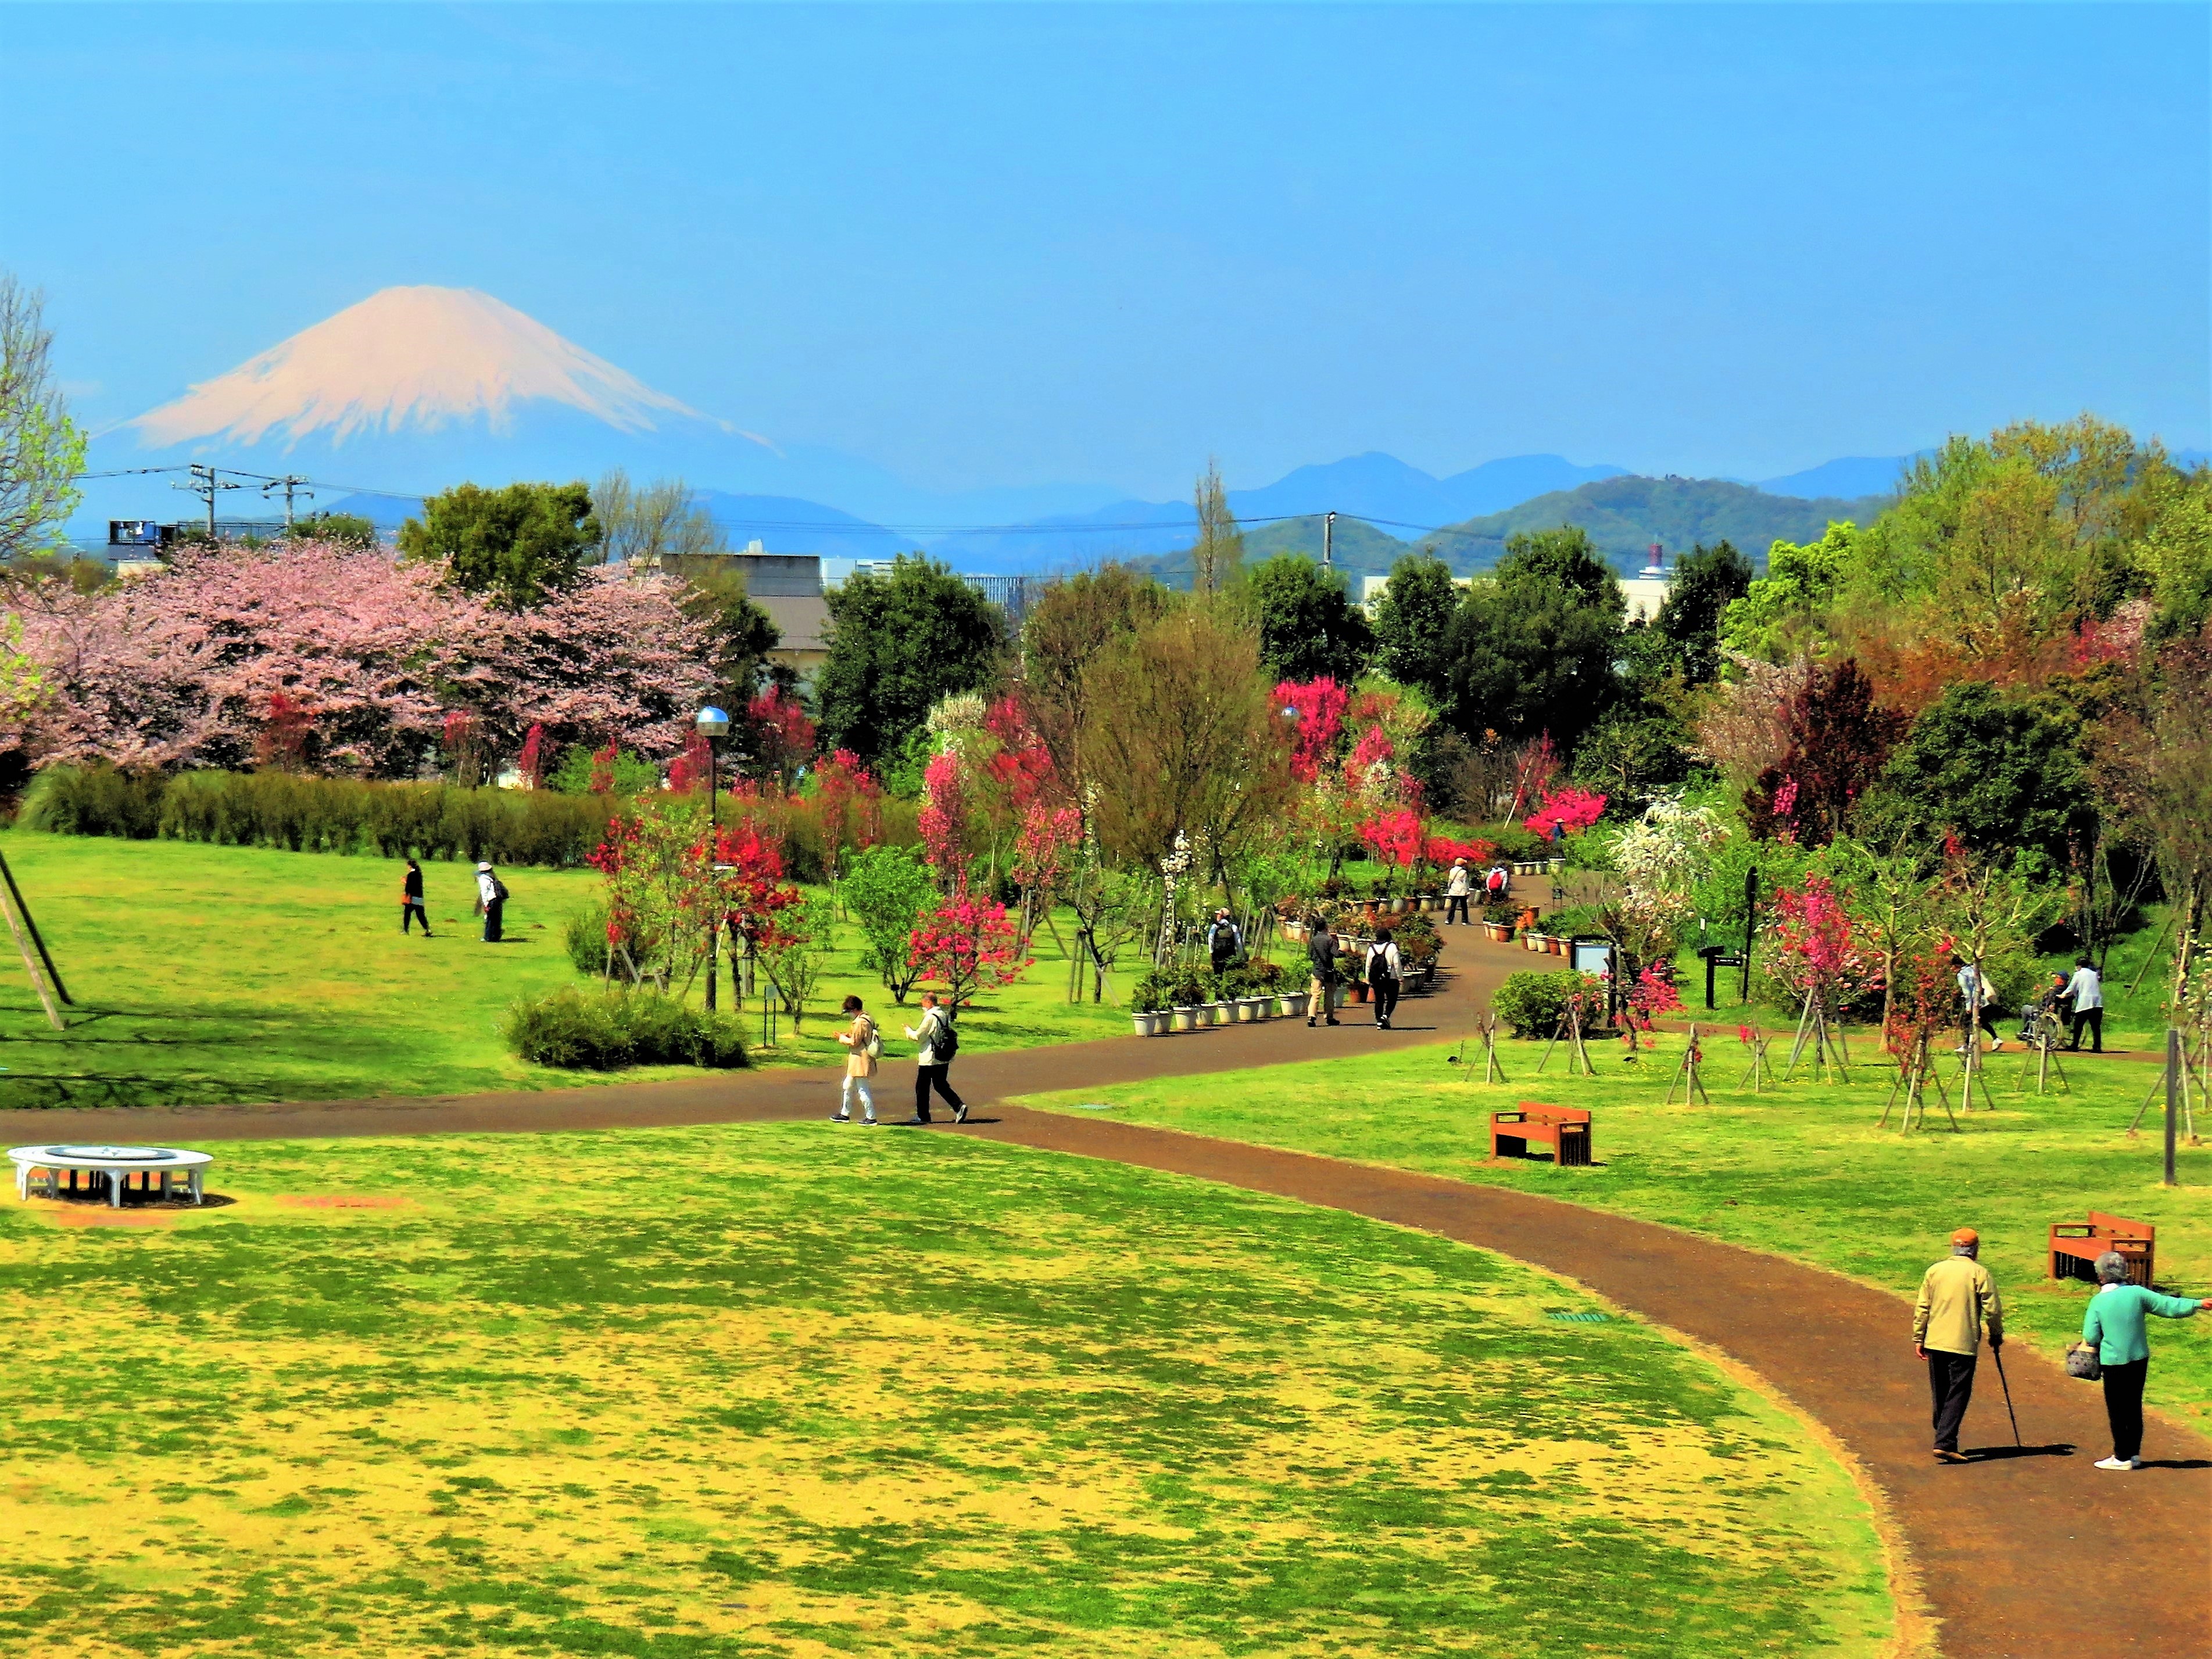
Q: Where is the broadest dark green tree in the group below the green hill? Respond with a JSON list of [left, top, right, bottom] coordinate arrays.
[[1444, 527, 1628, 748]]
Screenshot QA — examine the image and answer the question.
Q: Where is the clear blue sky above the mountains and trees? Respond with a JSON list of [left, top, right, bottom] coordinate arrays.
[[0, 5, 2212, 495]]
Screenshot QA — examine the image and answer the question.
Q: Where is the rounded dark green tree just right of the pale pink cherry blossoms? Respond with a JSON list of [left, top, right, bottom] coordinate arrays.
[[814, 553, 1007, 766]]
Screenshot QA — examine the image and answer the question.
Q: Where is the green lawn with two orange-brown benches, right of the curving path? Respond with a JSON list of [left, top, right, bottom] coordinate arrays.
[[1026, 1031, 2212, 1433]]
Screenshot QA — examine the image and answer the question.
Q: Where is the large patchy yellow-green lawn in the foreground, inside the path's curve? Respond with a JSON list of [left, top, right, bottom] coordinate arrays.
[[0, 1126, 1891, 1659]]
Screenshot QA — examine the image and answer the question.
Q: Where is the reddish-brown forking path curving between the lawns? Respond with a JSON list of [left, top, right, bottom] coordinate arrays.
[[0, 940, 2212, 1659]]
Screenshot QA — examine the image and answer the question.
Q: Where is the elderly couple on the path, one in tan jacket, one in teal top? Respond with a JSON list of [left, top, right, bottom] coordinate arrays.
[[1913, 1228, 2212, 1469]]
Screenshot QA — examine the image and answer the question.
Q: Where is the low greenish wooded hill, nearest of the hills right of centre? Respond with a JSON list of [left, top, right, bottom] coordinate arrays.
[[1420, 478, 1887, 571]]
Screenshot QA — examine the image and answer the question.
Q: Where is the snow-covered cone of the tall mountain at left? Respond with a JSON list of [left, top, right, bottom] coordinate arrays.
[[124, 285, 725, 449]]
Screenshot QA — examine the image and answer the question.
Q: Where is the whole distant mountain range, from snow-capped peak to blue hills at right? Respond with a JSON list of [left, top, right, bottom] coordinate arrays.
[[75, 288, 2201, 573]]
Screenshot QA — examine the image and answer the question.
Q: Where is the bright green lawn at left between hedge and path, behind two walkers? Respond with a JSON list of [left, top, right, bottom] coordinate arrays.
[[0, 832, 1128, 1108]]
